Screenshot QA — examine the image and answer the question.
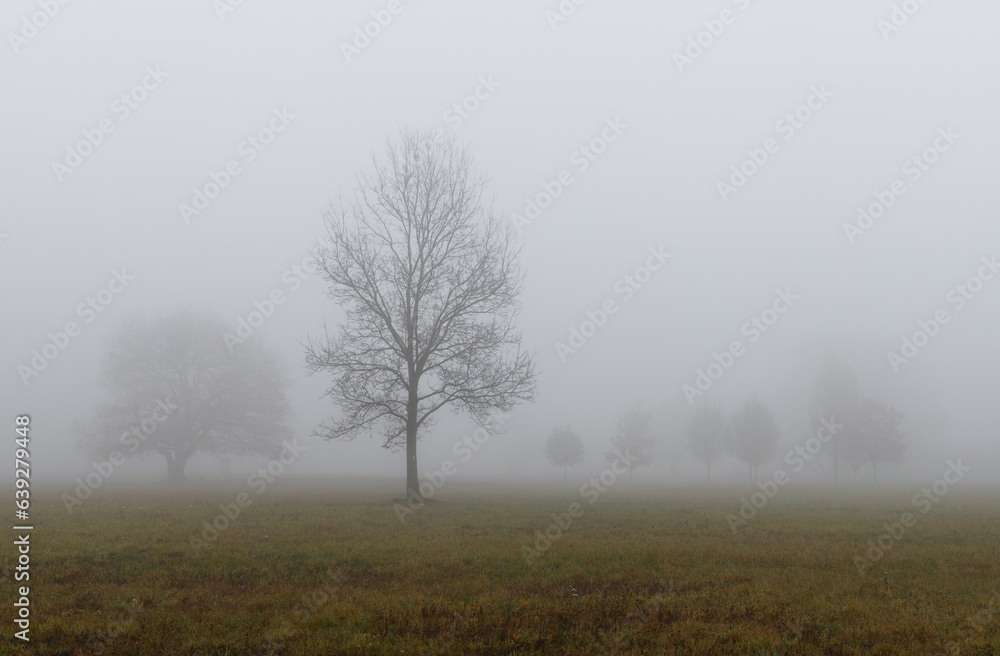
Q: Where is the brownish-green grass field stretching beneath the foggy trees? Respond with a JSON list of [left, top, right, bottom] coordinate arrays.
[[3, 481, 1000, 655]]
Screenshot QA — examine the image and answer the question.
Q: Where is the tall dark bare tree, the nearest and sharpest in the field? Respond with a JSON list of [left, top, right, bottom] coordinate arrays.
[[306, 130, 535, 502]]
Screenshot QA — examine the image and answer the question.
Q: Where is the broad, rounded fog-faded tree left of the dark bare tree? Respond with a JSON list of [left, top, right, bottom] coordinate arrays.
[[81, 311, 291, 481]]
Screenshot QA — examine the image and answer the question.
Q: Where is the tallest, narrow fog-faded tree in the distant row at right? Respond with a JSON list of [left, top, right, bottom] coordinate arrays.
[[809, 352, 860, 482]]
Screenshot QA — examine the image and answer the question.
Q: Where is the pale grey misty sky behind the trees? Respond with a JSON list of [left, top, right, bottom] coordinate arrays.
[[0, 0, 1000, 483]]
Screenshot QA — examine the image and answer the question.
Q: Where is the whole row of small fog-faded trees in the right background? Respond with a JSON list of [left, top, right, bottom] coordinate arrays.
[[545, 355, 906, 482]]
